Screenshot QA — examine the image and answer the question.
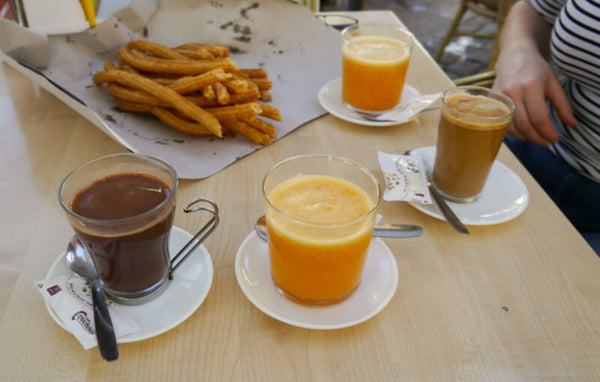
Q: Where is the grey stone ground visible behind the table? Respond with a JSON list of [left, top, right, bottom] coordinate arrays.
[[321, 0, 496, 79]]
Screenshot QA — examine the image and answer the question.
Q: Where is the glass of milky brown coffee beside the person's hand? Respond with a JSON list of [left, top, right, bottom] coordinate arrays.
[[432, 86, 515, 203]]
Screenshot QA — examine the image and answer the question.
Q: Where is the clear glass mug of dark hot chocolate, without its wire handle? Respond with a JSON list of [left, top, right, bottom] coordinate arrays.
[[59, 153, 218, 305]]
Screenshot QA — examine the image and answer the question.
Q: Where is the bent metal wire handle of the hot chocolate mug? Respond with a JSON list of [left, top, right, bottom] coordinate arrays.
[[169, 198, 219, 280]]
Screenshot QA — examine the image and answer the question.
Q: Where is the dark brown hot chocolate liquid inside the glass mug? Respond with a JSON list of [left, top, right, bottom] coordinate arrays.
[[71, 173, 174, 293]]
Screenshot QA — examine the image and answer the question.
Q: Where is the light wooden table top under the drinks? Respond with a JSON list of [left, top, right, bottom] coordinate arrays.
[[0, 12, 600, 381]]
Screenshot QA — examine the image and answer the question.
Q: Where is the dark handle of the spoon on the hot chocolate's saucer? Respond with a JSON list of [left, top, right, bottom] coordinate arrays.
[[90, 280, 119, 361]]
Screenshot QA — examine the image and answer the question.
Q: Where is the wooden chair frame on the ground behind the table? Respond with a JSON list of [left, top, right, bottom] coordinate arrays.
[[435, 0, 513, 70]]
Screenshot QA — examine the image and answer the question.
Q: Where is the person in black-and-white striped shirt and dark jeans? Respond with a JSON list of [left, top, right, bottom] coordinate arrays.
[[493, 0, 600, 255]]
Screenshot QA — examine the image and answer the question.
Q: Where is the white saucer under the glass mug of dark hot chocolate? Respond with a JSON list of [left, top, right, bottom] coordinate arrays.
[[46, 227, 213, 343]]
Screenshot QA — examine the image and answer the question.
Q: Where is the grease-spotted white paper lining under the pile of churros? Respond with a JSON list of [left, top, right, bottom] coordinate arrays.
[[0, 0, 342, 179]]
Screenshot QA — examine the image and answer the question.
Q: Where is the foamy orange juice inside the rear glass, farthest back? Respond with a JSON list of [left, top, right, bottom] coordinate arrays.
[[342, 36, 410, 111]]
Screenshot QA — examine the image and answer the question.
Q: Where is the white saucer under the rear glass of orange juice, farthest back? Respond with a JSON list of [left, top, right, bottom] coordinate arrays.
[[319, 78, 421, 126]]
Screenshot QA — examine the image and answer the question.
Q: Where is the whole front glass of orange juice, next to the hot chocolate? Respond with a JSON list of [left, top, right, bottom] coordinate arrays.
[[263, 154, 381, 305]]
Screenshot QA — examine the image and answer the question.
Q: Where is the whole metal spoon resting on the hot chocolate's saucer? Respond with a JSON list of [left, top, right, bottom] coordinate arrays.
[[66, 236, 119, 361]]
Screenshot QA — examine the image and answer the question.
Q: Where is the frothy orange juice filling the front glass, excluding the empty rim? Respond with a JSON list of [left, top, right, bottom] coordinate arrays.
[[267, 175, 374, 304]]
